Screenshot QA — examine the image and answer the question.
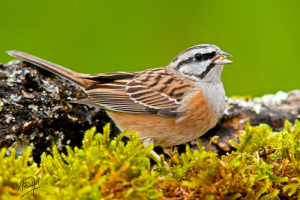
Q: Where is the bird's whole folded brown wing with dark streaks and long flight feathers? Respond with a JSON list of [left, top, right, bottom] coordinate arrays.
[[75, 68, 190, 117]]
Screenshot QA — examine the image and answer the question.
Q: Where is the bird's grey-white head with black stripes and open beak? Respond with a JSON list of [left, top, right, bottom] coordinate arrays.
[[168, 44, 232, 83]]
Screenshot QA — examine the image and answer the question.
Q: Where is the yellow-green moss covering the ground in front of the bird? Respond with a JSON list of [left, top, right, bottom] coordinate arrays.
[[0, 121, 300, 199]]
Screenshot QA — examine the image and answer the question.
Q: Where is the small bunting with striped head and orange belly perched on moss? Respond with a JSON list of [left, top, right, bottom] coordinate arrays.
[[7, 44, 232, 162]]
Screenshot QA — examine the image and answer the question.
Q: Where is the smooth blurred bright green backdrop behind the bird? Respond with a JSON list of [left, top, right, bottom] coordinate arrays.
[[0, 0, 300, 97]]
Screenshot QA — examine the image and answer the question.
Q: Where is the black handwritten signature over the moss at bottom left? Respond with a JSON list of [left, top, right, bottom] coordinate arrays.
[[18, 176, 40, 197]]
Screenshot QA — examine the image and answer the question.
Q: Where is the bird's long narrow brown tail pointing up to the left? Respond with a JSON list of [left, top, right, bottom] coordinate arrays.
[[7, 50, 90, 88]]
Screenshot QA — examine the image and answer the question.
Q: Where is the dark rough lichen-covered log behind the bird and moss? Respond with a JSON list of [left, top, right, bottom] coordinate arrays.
[[0, 62, 300, 162]]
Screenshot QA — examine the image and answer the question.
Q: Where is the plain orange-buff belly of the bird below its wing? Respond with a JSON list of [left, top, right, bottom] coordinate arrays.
[[106, 90, 220, 147]]
